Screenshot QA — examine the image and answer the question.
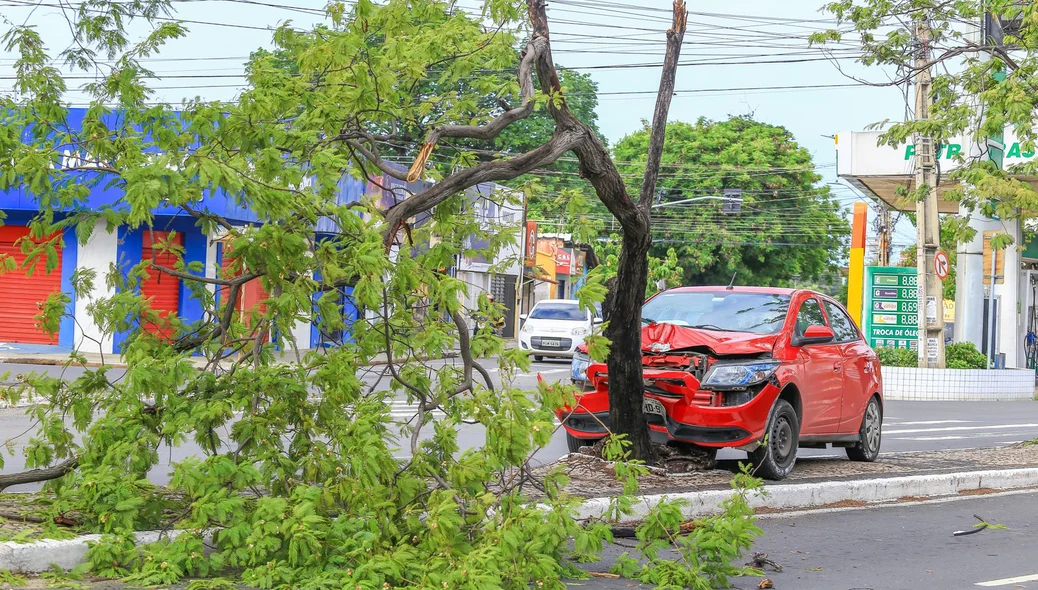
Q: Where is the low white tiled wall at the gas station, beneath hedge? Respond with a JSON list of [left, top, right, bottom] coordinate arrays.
[[881, 367, 1035, 401]]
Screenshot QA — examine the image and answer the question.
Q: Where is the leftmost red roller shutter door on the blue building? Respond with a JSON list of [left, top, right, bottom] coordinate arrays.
[[0, 225, 61, 345]]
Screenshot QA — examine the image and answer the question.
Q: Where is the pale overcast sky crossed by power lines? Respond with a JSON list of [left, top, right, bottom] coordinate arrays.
[[0, 0, 913, 251]]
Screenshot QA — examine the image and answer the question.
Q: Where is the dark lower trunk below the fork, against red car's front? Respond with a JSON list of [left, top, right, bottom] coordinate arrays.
[[605, 227, 652, 459]]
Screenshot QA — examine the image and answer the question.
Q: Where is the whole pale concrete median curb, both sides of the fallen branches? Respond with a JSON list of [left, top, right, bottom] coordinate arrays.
[[0, 467, 1038, 573]]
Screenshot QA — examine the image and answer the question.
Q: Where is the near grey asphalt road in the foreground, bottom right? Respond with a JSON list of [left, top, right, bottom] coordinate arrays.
[[570, 491, 1038, 590]]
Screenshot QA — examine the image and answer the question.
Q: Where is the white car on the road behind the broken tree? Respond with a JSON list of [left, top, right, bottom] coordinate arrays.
[[519, 299, 602, 360]]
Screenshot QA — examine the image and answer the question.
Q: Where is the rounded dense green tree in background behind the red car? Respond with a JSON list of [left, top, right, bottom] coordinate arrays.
[[613, 116, 850, 287]]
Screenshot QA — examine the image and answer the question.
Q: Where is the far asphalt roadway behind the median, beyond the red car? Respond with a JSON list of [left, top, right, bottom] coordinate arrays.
[[0, 359, 1038, 490]]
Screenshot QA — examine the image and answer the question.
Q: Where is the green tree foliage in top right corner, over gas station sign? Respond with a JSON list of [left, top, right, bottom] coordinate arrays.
[[812, 0, 1038, 233]]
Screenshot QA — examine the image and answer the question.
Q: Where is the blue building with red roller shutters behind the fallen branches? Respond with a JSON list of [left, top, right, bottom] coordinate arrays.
[[0, 109, 381, 353]]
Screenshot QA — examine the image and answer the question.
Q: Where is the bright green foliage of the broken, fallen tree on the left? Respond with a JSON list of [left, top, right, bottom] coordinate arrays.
[[0, 0, 763, 590]]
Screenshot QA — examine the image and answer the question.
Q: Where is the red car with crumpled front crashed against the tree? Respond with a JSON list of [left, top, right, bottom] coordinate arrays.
[[558, 287, 883, 480]]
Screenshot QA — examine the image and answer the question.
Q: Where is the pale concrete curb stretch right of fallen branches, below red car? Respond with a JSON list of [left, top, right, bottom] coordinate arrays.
[[577, 467, 1038, 522]]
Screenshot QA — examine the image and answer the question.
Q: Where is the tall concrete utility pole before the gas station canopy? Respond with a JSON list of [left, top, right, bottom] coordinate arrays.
[[914, 16, 945, 369]]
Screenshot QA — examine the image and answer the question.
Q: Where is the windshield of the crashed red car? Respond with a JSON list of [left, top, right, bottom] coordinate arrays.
[[641, 291, 789, 334]]
